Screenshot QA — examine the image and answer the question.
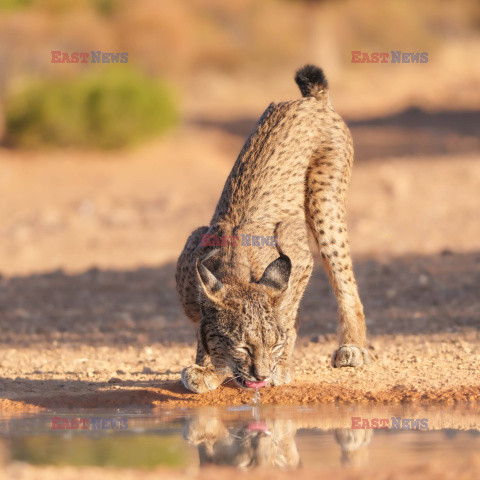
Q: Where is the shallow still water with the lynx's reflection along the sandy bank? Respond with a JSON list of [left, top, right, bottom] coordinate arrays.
[[0, 404, 480, 469]]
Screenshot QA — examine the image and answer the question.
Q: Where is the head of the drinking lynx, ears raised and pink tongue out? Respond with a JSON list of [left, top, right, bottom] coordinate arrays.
[[197, 249, 292, 388]]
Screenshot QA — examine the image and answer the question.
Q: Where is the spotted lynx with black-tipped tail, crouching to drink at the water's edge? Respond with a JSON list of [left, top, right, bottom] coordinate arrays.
[[176, 65, 370, 393]]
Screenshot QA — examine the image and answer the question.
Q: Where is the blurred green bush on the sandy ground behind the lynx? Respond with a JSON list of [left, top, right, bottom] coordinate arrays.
[[6, 69, 177, 149]]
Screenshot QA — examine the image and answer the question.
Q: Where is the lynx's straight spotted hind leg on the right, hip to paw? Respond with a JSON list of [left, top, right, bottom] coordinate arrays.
[[307, 139, 370, 367]]
